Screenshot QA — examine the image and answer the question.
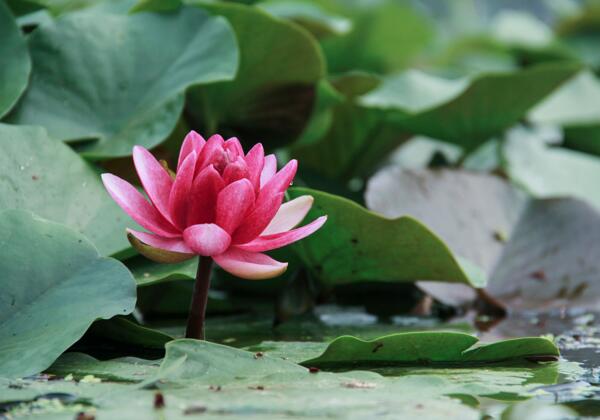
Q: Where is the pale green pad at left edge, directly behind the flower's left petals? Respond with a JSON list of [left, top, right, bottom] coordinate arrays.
[[0, 124, 135, 255]]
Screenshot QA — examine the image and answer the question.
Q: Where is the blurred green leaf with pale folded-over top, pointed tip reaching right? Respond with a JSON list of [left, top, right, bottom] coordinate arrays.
[[361, 63, 580, 151]]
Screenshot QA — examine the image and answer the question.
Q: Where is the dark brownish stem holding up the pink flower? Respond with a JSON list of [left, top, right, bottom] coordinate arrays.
[[185, 257, 212, 340]]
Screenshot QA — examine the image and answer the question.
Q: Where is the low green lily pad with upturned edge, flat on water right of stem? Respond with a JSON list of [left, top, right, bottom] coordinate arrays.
[[302, 331, 560, 367]]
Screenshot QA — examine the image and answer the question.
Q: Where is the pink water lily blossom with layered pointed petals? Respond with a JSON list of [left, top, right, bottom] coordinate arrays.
[[102, 131, 327, 279]]
